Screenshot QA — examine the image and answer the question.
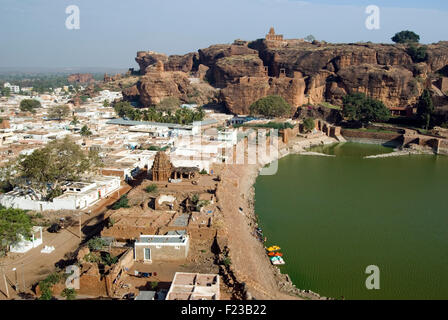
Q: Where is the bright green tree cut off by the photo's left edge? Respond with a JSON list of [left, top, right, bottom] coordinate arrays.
[[0, 208, 33, 252]]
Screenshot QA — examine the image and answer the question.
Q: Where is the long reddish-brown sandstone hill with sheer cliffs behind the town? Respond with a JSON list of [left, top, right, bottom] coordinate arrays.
[[124, 31, 448, 114]]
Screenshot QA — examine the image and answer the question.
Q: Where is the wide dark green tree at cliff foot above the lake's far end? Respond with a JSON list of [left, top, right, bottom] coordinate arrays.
[[342, 92, 390, 124]]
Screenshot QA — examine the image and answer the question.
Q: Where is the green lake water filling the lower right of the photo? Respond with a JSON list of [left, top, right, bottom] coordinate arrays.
[[255, 143, 448, 299]]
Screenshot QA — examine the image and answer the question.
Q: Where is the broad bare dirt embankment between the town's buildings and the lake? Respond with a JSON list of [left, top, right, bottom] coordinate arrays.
[[218, 165, 298, 300]]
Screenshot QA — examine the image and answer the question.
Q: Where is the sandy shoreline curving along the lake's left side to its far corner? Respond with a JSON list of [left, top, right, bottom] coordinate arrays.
[[217, 136, 338, 300]]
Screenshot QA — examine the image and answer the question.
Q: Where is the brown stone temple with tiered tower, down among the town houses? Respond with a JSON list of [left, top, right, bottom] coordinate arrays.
[[151, 151, 199, 181]]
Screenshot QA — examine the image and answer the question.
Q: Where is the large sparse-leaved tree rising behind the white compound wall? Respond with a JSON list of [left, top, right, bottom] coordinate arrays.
[[9, 137, 101, 200]]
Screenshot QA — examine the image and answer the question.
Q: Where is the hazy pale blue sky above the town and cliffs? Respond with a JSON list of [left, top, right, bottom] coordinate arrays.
[[0, 0, 448, 68]]
